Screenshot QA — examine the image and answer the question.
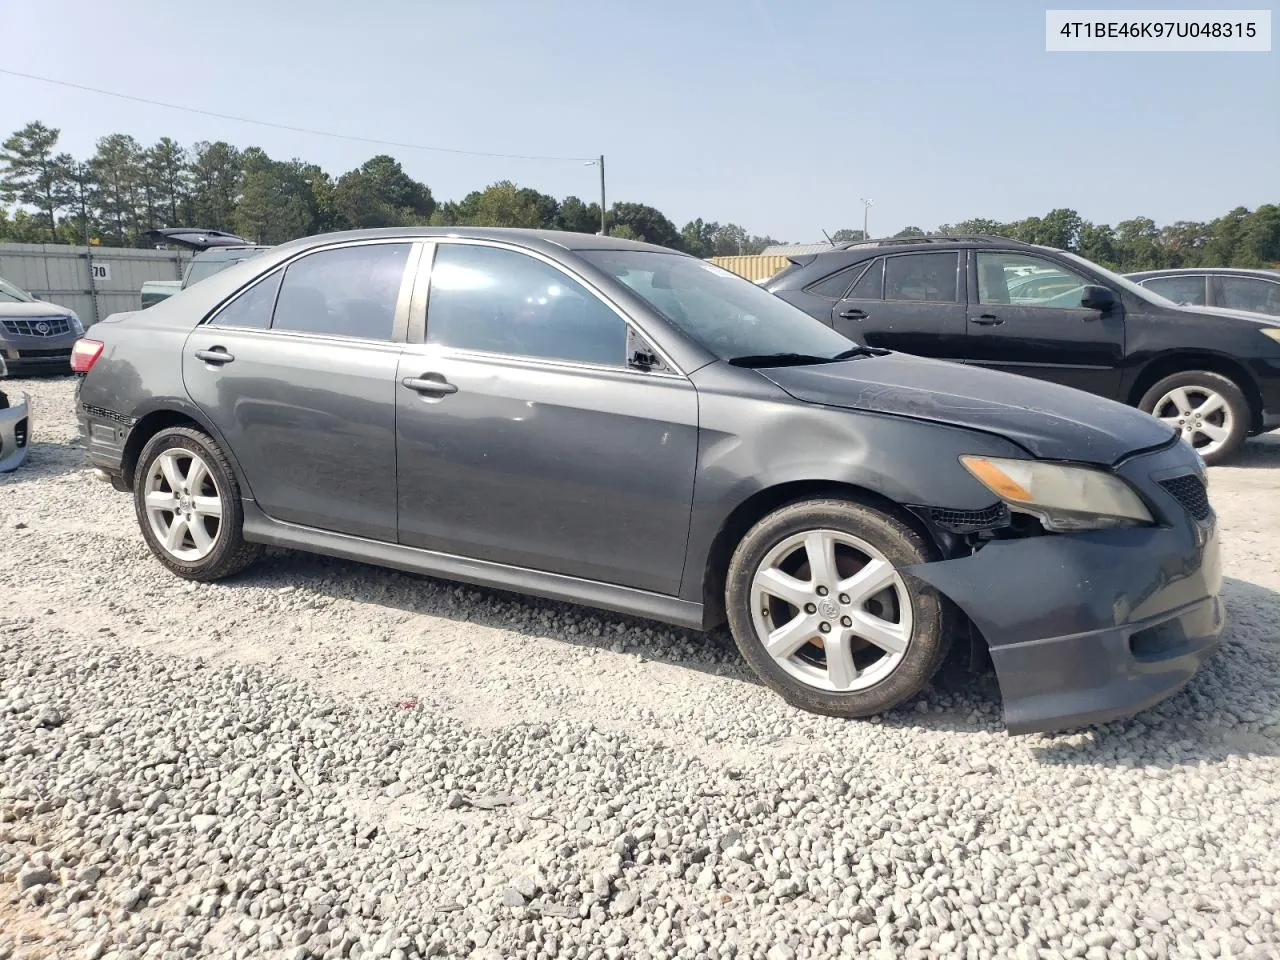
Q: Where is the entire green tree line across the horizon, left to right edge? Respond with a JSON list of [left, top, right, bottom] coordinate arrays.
[[0, 122, 1280, 271]]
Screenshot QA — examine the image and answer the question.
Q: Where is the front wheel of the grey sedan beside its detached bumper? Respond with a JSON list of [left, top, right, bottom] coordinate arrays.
[[724, 499, 951, 718]]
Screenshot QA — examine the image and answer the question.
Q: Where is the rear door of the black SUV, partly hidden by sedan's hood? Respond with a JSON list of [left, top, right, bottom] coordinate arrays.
[[831, 250, 965, 360]]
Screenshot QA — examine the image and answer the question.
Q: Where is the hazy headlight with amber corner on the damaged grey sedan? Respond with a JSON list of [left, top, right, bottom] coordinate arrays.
[[960, 457, 1155, 532]]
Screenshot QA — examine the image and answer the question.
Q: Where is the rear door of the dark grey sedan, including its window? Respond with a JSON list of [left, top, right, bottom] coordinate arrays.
[[182, 241, 421, 543]]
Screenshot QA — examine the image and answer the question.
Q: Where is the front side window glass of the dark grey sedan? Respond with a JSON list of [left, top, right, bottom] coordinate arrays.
[[426, 243, 627, 366]]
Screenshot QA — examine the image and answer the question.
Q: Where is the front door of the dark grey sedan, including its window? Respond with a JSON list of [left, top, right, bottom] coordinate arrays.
[[397, 239, 698, 594]]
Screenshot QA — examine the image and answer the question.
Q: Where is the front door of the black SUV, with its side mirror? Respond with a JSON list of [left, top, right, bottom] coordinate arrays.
[[965, 250, 1124, 397]]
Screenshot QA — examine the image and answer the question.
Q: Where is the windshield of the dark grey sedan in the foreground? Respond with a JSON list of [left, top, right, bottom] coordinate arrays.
[[577, 250, 856, 360]]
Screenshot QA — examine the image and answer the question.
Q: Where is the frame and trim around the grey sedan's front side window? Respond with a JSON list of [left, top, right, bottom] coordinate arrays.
[[419, 237, 689, 380]]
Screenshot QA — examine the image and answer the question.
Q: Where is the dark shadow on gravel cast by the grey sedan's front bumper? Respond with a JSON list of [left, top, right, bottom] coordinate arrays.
[[1033, 577, 1280, 768]]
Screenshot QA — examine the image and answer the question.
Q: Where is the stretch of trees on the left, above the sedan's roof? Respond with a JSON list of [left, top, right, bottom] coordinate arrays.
[[0, 122, 777, 257]]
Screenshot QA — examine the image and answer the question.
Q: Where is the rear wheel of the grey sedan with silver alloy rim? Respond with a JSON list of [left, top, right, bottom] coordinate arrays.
[[133, 426, 261, 581]]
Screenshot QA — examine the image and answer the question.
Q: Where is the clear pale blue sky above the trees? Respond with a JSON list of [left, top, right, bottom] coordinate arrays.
[[0, 0, 1280, 241]]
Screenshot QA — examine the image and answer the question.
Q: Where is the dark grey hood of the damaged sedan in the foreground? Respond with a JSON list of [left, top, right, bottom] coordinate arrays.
[[758, 353, 1178, 465]]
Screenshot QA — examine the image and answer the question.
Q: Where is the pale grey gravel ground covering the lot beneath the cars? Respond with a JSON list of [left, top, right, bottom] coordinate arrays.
[[0, 378, 1280, 960]]
